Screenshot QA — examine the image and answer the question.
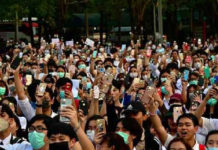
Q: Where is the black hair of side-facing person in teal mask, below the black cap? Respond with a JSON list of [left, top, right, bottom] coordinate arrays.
[[117, 117, 143, 146]]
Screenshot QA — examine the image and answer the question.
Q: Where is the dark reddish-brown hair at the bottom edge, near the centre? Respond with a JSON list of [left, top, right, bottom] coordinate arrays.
[[101, 133, 130, 150]]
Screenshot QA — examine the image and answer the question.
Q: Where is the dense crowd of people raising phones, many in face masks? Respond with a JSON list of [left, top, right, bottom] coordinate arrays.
[[0, 36, 218, 150]]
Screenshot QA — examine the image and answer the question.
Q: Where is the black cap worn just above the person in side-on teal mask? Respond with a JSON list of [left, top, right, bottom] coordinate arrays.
[[123, 101, 146, 116]]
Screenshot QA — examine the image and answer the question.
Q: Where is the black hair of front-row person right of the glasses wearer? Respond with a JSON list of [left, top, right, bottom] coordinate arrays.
[[48, 122, 78, 140]]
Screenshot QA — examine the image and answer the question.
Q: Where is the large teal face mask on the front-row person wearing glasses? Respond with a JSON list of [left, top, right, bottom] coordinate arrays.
[[28, 131, 45, 149]]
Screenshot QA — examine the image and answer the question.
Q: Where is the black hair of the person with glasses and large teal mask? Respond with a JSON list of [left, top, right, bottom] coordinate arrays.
[[27, 115, 53, 129]]
